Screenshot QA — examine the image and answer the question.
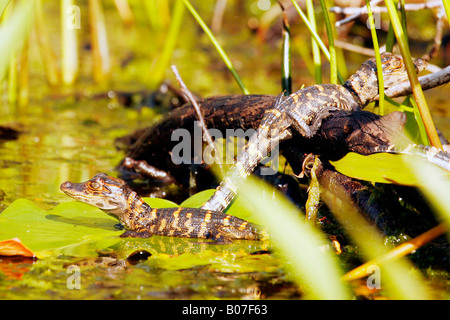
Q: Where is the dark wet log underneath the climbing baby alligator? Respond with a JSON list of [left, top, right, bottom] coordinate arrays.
[[114, 95, 448, 230]]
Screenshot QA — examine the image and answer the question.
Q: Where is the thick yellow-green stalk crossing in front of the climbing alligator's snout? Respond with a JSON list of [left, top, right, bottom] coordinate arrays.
[[385, 0, 442, 149]]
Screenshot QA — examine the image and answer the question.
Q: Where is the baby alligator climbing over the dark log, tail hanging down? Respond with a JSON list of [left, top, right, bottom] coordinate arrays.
[[201, 52, 426, 212]]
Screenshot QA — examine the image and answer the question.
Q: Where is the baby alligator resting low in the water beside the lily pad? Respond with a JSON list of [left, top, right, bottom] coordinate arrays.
[[60, 173, 266, 243]]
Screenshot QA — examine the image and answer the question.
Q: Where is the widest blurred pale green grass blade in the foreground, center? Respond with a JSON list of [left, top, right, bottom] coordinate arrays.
[[241, 177, 350, 299]]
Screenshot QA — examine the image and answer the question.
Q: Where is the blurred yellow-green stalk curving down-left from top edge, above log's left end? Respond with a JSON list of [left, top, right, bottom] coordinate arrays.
[[150, 0, 185, 88]]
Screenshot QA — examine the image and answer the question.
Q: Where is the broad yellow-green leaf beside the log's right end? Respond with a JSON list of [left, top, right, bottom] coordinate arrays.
[[330, 152, 448, 186]]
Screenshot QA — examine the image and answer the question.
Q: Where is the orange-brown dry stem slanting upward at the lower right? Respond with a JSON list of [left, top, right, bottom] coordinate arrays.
[[342, 223, 446, 281]]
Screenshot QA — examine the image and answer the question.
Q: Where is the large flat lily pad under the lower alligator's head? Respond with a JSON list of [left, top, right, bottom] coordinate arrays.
[[0, 198, 181, 258]]
